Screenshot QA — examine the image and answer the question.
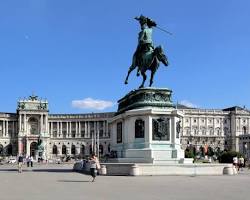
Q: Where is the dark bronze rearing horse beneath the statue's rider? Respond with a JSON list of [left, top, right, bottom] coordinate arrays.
[[125, 46, 168, 88]]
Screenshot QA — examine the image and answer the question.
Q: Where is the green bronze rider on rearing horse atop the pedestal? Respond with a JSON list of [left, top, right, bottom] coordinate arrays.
[[125, 15, 168, 88]]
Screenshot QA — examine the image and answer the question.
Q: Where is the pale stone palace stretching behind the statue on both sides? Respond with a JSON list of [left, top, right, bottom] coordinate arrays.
[[0, 95, 250, 159]]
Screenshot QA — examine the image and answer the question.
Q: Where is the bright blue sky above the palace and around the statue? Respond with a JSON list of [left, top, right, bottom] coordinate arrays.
[[0, 0, 250, 113]]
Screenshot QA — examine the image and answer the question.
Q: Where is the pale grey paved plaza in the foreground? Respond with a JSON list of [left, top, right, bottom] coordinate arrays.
[[0, 164, 250, 200]]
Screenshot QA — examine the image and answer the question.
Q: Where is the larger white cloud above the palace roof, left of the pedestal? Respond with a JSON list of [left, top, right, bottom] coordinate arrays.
[[72, 97, 114, 110]]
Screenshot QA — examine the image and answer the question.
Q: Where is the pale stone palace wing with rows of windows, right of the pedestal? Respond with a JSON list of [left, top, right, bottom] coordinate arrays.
[[180, 107, 250, 156]]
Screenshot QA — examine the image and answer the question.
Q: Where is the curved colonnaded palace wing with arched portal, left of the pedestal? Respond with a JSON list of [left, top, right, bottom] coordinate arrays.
[[0, 96, 114, 159]]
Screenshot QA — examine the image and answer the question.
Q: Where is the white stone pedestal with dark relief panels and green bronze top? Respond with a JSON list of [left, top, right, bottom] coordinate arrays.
[[111, 88, 184, 164]]
